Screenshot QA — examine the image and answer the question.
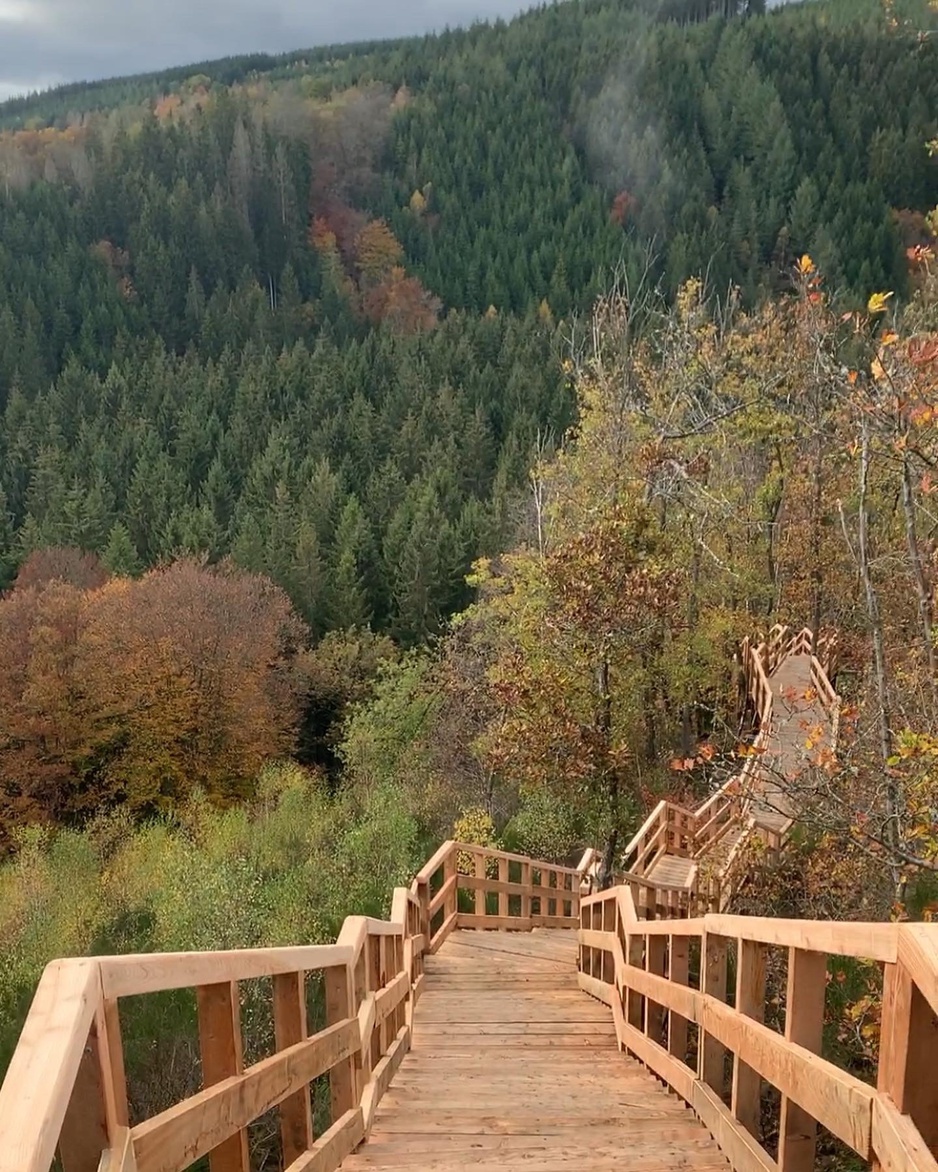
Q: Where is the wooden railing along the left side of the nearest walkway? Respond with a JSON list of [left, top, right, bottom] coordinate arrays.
[[0, 843, 580, 1172]]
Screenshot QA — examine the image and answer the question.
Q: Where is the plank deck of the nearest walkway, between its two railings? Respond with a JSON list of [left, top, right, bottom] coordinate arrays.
[[342, 929, 728, 1172]]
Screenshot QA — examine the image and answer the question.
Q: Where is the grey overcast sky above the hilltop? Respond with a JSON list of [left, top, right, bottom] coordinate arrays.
[[0, 0, 531, 98]]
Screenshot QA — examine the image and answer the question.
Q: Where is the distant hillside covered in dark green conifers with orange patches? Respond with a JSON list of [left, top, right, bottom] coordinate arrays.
[[0, 0, 938, 641]]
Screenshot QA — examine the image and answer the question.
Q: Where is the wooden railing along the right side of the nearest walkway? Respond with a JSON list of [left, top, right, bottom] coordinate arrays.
[[578, 886, 938, 1172]]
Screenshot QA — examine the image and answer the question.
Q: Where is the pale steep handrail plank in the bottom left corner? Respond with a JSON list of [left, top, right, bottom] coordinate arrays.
[[0, 960, 101, 1172]]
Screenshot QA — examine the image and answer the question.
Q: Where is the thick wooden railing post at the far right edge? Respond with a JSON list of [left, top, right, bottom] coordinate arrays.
[[877, 956, 938, 1156]]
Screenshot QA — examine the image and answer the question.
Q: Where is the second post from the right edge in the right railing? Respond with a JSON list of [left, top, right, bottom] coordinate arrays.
[[779, 948, 828, 1172]]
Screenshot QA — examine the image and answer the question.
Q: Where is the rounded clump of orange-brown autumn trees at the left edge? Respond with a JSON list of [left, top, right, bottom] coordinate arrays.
[[0, 561, 306, 832]]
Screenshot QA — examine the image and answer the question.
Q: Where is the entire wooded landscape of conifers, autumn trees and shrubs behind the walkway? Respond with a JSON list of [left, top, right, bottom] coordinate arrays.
[[0, 0, 938, 1115]]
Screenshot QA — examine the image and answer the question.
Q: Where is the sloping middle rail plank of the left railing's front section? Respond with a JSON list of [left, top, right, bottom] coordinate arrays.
[[132, 1018, 359, 1172]]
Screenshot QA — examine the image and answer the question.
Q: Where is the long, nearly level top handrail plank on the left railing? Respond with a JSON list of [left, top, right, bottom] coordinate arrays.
[[100, 942, 351, 1000]]
